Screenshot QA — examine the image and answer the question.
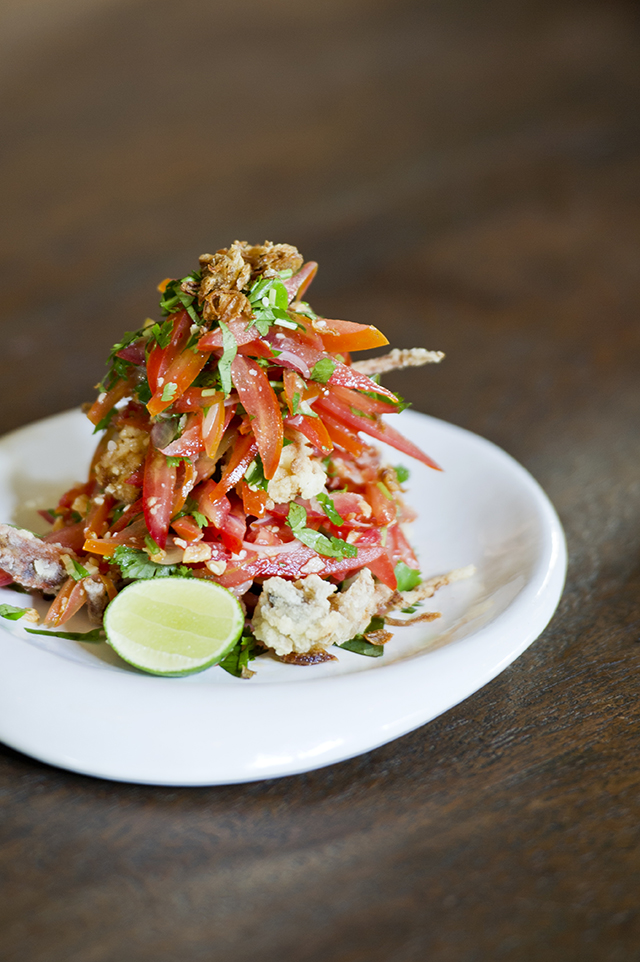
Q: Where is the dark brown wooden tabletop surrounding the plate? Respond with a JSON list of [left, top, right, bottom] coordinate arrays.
[[0, 0, 640, 962]]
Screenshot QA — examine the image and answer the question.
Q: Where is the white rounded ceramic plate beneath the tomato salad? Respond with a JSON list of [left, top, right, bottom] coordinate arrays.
[[0, 411, 566, 785]]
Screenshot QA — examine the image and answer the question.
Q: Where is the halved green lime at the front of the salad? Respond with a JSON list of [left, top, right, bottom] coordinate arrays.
[[104, 578, 244, 675]]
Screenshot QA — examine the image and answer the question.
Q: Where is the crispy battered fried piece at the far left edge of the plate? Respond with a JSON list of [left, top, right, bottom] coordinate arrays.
[[0, 524, 69, 591]]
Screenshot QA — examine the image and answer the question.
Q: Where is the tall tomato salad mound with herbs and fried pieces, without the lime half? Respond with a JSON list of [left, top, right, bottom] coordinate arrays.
[[0, 241, 463, 676]]
